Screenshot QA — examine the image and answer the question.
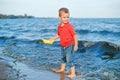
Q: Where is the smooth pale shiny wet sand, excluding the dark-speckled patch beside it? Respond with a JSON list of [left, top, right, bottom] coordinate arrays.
[[13, 63, 68, 80]]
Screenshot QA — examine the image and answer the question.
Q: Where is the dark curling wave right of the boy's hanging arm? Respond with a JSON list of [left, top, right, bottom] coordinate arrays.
[[78, 41, 120, 60]]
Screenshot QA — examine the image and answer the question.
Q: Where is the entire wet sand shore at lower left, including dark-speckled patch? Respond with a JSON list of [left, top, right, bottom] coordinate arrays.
[[0, 59, 69, 80]]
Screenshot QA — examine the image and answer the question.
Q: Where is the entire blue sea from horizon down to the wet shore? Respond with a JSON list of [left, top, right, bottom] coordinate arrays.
[[0, 18, 120, 80]]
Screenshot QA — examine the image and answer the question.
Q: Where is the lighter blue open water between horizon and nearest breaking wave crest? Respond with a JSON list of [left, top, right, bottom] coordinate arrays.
[[0, 18, 120, 44]]
